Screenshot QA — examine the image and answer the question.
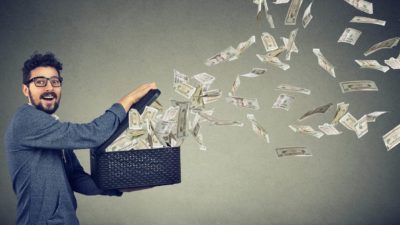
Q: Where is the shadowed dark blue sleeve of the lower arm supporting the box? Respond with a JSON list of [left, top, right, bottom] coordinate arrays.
[[65, 150, 122, 196]]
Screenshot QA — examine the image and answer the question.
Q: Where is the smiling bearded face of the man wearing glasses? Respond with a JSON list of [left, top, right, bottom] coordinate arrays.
[[22, 66, 61, 114]]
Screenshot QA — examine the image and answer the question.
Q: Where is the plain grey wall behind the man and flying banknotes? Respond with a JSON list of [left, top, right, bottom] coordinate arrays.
[[0, 0, 400, 225]]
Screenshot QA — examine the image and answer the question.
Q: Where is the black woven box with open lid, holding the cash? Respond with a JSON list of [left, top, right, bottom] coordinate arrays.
[[90, 90, 181, 190]]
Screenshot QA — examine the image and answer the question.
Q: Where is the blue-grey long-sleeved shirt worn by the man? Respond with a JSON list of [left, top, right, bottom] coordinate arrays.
[[5, 103, 126, 225]]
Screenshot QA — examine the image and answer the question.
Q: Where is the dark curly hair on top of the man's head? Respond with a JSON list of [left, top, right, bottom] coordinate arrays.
[[22, 52, 62, 84]]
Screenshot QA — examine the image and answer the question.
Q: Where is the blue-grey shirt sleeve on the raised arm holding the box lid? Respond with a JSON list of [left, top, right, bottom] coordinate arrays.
[[13, 103, 126, 150]]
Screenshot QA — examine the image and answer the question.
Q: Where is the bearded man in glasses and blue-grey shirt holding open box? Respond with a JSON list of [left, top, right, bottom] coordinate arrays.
[[5, 53, 156, 225]]
